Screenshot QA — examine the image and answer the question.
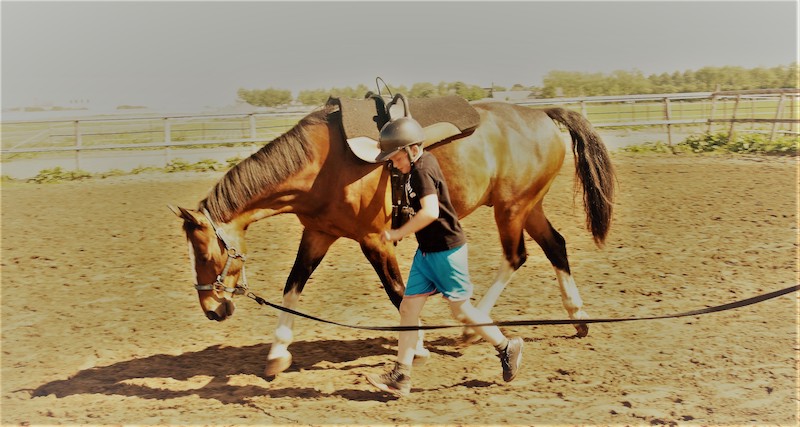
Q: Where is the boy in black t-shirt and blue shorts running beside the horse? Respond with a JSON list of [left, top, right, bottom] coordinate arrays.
[[367, 141, 522, 396]]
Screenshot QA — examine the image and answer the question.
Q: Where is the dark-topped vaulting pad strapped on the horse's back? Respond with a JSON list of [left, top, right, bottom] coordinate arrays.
[[326, 92, 480, 163]]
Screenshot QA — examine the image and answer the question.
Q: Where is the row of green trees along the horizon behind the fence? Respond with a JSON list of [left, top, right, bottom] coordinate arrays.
[[237, 63, 800, 107]]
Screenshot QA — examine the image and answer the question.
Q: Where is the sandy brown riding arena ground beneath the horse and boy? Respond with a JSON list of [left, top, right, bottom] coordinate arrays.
[[0, 150, 800, 426]]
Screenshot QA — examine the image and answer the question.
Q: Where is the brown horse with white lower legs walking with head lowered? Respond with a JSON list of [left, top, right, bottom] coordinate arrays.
[[173, 102, 615, 376]]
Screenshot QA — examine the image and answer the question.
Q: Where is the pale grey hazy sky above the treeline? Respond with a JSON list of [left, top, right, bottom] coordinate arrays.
[[0, 0, 798, 108]]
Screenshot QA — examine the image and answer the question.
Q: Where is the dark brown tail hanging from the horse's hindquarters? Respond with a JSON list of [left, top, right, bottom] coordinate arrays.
[[544, 108, 616, 246]]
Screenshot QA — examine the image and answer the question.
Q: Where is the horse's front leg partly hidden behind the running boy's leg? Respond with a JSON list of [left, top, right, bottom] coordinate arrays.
[[360, 234, 430, 363]]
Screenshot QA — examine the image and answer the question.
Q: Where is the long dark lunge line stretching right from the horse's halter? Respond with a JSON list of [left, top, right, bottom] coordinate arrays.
[[245, 285, 800, 331]]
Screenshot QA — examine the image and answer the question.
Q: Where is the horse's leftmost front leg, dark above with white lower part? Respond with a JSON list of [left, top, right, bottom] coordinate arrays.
[[264, 228, 338, 377]]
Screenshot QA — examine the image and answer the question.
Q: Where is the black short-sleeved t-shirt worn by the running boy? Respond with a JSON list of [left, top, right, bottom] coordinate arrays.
[[406, 151, 467, 252]]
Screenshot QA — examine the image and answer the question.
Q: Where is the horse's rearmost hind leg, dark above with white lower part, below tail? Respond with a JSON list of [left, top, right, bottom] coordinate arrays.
[[525, 203, 589, 337]]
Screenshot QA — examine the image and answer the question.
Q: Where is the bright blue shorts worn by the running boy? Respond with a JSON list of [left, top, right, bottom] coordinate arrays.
[[405, 245, 472, 301]]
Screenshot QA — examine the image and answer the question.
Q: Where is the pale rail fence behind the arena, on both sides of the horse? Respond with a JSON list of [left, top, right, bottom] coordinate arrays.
[[0, 89, 800, 178]]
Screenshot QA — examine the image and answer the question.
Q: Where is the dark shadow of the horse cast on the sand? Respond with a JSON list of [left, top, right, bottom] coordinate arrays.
[[31, 338, 406, 404]]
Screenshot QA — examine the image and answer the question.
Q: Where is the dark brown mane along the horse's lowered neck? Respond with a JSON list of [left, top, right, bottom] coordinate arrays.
[[200, 106, 333, 222]]
